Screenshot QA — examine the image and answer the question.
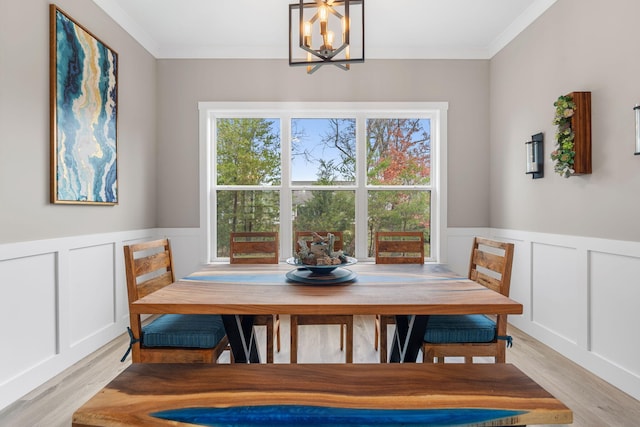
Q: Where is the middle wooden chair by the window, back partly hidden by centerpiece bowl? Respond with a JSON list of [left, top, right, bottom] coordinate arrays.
[[291, 231, 353, 363]]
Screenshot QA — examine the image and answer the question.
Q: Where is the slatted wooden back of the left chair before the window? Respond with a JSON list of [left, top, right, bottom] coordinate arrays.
[[229, 231, 279, 264]]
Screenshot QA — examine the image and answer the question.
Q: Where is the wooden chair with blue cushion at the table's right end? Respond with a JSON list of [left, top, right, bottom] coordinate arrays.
[[422, 237, 514, 363]]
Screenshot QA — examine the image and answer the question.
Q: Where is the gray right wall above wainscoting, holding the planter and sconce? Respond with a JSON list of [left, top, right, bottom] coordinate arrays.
[[490, 0, 640, 241]]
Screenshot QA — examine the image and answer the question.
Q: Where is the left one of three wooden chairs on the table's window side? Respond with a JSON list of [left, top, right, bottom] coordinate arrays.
[[229, 231, 280, 363]]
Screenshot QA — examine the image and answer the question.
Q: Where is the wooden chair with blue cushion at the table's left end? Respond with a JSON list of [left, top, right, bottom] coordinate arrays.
[[122, 239, 229, 363]]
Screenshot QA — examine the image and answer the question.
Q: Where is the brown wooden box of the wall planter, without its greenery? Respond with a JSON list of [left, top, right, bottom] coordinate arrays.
[[567, 92, 591, 175]]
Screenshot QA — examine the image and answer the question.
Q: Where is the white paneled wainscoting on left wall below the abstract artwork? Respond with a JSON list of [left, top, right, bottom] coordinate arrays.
[[0, 230, 157, 409]]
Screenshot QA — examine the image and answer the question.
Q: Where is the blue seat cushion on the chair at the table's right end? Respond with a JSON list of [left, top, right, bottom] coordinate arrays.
[[424, 314, 496, 344]]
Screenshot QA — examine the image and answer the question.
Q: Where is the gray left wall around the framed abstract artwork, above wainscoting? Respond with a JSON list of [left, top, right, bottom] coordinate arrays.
[[0, 0, 157, 243]]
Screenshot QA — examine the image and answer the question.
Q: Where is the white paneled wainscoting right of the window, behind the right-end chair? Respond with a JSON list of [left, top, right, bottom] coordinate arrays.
[[448, 228, 640, 399]]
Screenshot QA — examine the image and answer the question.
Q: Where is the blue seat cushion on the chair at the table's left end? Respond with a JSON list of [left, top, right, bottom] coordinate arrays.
[[142, 314, 225, 348]]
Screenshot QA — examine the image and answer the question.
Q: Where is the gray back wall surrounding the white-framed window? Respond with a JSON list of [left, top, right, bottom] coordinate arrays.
[[158, 59, 489, 231]]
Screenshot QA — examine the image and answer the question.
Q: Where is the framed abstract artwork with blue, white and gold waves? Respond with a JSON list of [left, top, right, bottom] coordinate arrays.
[[50, 4, 118, 205]]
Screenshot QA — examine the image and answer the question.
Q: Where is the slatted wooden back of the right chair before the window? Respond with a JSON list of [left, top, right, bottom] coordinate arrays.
[[375, 231, 424, 264]]
